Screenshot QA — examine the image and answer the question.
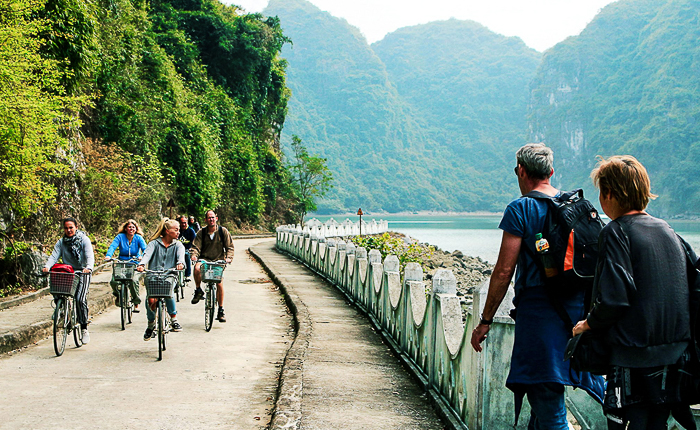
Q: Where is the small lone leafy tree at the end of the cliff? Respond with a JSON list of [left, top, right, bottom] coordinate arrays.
[[289, 135, 333, 224]]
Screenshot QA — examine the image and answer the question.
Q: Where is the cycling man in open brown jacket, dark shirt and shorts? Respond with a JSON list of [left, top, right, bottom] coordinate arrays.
[[190, 210, 233, 322]]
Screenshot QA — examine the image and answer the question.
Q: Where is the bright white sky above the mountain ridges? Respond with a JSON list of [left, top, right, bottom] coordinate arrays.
[[222, 0, 615, 52]]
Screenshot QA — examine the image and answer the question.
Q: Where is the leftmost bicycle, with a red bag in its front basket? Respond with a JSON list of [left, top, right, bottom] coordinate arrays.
[[46, 271, 91, 357]]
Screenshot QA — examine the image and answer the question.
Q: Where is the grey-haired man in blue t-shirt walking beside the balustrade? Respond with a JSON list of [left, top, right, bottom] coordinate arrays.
[[471, 143, 603, 430]]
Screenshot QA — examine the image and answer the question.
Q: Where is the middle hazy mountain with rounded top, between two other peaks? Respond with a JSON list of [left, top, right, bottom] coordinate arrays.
[[372, 19, 541, 210]]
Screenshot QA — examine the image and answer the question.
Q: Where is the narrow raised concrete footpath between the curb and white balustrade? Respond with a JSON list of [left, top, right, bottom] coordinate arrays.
[[252, 242, 444, 430]]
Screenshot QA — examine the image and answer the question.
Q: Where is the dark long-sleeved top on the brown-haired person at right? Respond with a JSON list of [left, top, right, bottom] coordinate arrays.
[[588, 214, 690, 368]]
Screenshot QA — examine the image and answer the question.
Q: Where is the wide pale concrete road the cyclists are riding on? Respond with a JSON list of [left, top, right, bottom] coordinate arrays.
[[0, 239, 291, 430]]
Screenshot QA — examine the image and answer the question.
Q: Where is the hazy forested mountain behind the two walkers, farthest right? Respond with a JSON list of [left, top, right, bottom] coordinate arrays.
[[529, 0, 700, 216]]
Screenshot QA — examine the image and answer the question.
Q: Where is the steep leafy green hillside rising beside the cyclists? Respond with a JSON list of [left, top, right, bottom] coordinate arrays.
[[0, 0, 294, 244]]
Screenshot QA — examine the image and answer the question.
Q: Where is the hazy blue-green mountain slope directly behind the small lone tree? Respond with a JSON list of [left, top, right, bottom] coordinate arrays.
[[264, 0, 448, 211]]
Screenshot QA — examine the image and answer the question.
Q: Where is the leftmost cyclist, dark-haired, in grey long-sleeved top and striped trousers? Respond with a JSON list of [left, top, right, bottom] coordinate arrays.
[[42, 217, 95, 345]]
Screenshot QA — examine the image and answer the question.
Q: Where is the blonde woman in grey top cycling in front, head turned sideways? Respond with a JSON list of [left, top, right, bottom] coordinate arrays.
[[136, 218, 185, 341]]
